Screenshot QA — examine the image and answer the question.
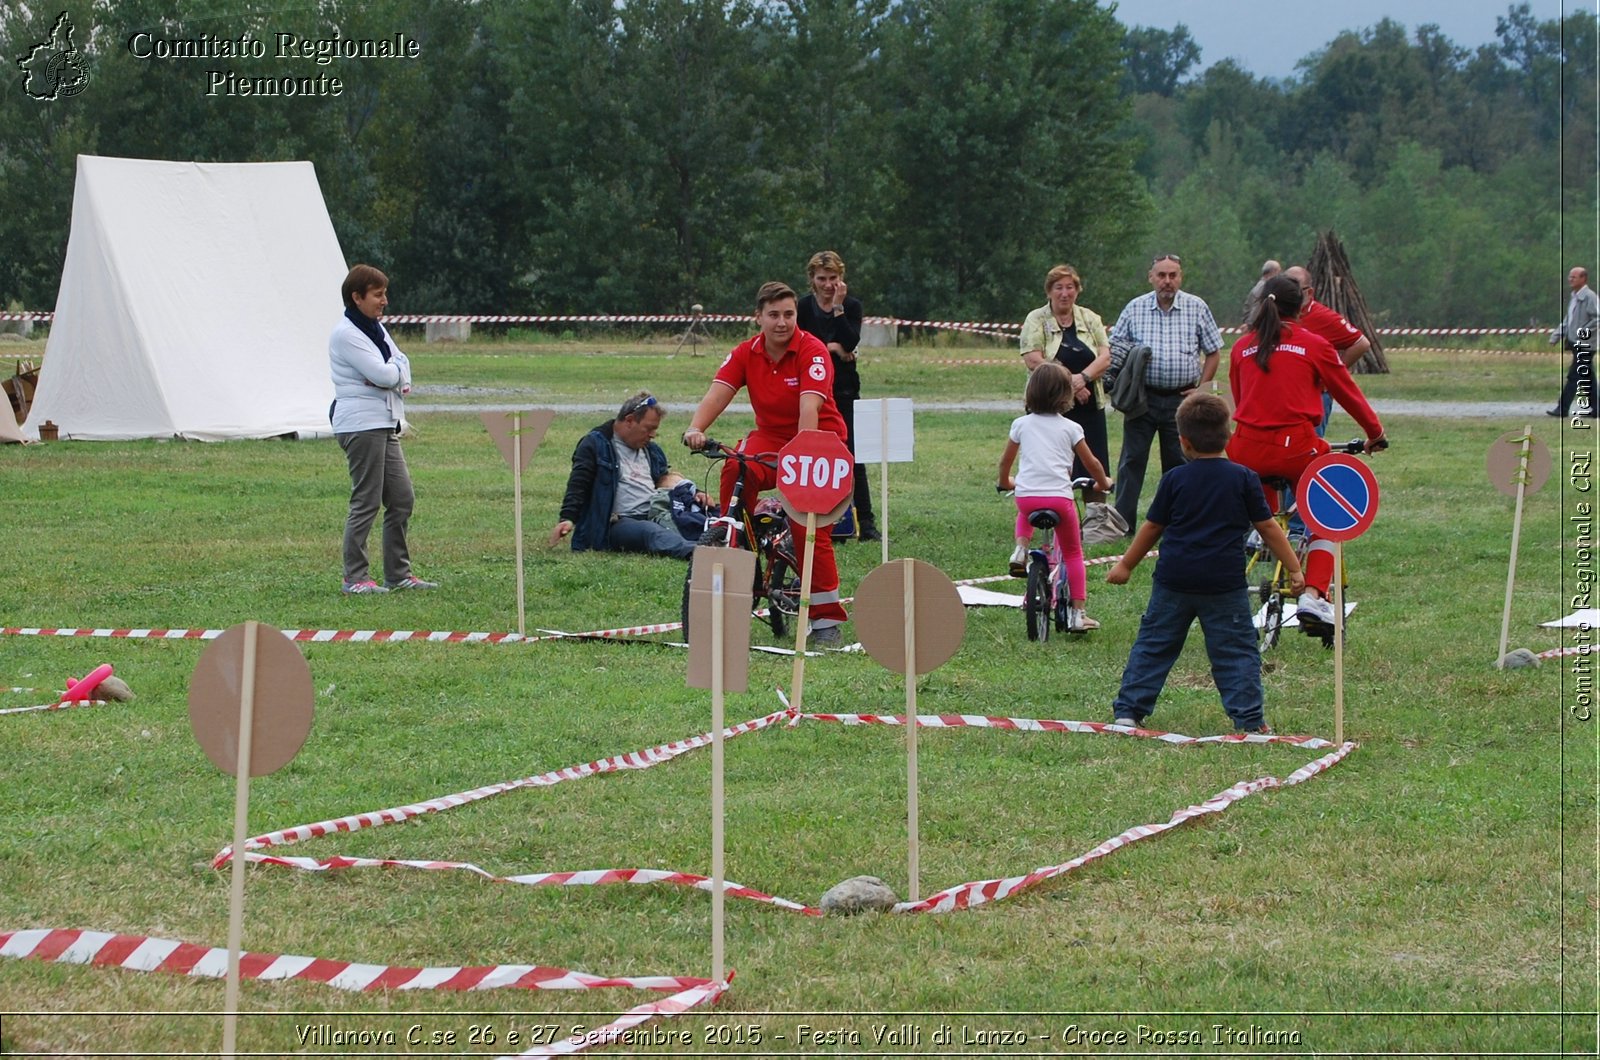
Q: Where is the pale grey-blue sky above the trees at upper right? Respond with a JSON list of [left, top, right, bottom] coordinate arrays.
[[1107, 0, 1574, 77]]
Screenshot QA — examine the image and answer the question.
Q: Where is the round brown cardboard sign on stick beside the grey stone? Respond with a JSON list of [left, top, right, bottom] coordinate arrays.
[[851, 559, 966, 674]]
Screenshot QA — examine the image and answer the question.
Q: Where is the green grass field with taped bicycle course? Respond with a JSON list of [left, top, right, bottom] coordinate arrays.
[[0, 339, 1600, 1055]]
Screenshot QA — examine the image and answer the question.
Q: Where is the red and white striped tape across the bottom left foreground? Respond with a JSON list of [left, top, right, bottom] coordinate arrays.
[[0, 929, 733, 1057]]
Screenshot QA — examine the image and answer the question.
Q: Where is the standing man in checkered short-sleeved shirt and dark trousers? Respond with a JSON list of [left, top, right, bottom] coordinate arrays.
[[1107, 255, 1222, 527]]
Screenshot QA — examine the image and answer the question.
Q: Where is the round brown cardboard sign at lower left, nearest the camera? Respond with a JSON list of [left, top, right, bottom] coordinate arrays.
[[189, 623, 312, 777]]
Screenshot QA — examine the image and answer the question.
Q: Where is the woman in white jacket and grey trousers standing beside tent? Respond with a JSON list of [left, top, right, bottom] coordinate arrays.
[[328, 264, 438, 594]]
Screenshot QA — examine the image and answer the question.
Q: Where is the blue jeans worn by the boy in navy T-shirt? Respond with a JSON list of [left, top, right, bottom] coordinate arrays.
[[1112, 583, 1266, 729]]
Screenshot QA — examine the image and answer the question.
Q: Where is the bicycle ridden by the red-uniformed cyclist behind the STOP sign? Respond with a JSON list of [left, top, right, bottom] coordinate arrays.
[[683, 437, 800, 640]]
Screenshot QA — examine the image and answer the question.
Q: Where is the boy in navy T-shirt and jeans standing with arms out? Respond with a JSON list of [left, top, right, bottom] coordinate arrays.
[[1106, 392, 1306, 733]]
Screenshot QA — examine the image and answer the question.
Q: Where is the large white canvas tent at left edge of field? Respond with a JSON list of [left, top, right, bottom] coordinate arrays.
[[22, 155, 346, 440]]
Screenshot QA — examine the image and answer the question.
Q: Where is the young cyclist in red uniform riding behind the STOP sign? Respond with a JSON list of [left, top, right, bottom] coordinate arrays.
[[683, 282, 848, 644]]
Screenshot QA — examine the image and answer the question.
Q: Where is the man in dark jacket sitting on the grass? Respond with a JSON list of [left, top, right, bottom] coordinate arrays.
[[550, 391, 707, 559]]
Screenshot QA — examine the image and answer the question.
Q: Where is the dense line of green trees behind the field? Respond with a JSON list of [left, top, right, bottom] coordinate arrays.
[[0, 0, 1600, 327]]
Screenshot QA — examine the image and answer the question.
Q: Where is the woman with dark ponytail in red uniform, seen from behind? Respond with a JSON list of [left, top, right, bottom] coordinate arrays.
[[1227, 275, 1384, 634]]
